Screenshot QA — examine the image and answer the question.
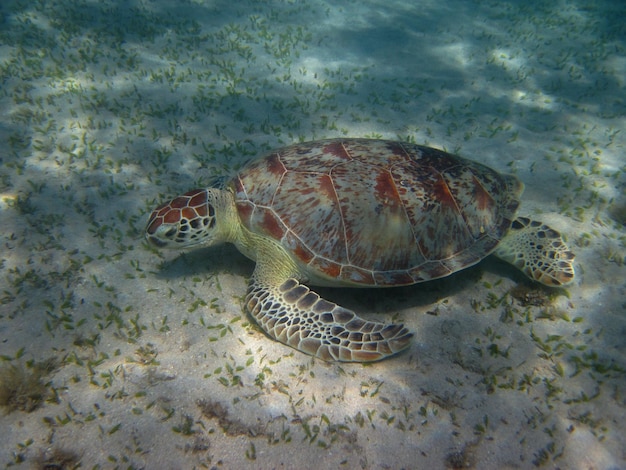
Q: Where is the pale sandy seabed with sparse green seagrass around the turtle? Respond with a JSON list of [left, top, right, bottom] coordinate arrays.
[[0, 0, 626, 469]]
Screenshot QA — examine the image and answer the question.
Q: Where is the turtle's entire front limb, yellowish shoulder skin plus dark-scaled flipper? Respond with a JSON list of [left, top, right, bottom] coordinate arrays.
[[236, 227, 413, 362]]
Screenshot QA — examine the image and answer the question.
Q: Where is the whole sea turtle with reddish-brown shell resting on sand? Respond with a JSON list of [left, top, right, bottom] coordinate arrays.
[[146, 139, 574, 362]]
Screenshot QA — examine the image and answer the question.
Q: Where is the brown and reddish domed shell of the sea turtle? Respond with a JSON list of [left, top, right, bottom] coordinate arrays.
[[229, 139, 523, 286]]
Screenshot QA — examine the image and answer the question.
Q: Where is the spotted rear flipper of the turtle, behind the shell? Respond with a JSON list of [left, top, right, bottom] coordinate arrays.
[[495, 217, 575, 287]]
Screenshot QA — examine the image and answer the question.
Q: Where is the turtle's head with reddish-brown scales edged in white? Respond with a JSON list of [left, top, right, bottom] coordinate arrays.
[[146, 189, 224, 248]]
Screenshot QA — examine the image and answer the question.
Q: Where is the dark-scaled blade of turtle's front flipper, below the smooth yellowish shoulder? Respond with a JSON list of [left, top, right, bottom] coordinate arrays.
[[246, 273, 413, 362]]
